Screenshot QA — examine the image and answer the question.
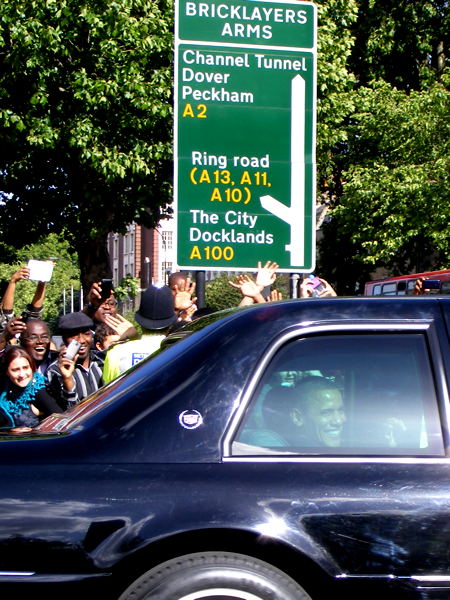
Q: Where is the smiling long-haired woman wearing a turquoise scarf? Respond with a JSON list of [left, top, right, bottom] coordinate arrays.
[[0, 346, 62, 430]]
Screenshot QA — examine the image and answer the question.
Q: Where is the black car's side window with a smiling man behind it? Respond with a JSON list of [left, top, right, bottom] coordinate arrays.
[[232, 333, 444, 456]]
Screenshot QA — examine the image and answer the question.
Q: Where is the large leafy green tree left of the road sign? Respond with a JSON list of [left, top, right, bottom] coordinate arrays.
[[0, 0, 173, 288]]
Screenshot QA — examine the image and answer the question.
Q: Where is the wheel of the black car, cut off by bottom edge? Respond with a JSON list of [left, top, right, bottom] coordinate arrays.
[[119, 552, 311, 600]]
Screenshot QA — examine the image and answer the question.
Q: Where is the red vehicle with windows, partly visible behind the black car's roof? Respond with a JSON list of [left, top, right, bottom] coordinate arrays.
[[364, 269, 450, 296]]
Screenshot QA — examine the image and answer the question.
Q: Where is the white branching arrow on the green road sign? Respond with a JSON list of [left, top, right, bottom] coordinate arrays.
[[260, 75, 305, 266]]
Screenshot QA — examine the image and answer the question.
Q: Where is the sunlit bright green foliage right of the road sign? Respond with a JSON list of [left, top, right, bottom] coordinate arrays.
[[334, 82, 450, 265]]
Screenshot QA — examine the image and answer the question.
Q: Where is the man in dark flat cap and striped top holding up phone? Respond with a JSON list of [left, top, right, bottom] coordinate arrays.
[[47, 312, 103, 410]]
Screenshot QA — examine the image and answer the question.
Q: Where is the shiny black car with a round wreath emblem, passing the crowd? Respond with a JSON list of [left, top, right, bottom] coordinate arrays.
[[0, 297, 450, 600]]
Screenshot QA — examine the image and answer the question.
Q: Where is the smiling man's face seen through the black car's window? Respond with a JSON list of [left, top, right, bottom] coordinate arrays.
[[306, 389, 346, 446]]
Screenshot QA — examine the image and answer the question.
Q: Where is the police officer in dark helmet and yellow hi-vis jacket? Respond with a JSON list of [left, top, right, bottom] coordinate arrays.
[[103, 285, 177, 383]]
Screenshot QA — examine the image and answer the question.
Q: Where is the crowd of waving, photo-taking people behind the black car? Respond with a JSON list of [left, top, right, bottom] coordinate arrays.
[[0, 261, 336, 433]]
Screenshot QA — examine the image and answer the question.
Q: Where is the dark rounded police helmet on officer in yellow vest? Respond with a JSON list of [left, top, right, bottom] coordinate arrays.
[[134, 285, 177, 329]]
